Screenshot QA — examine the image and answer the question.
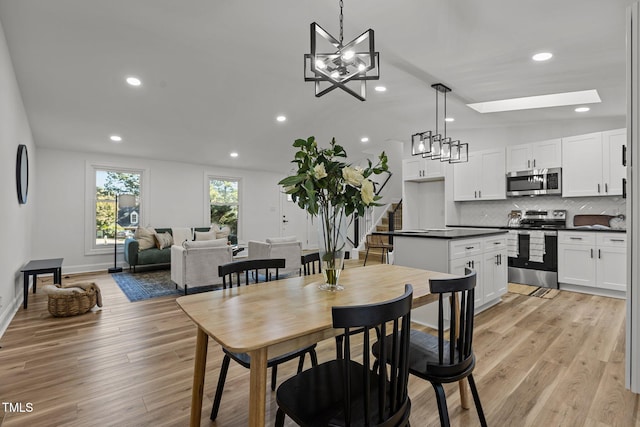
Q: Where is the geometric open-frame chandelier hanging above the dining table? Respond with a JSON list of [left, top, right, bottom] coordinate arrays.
[[304, 0, 380, 101]]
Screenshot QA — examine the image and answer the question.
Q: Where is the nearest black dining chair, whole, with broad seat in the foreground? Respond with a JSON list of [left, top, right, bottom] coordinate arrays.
[[275, 285, 413, 427]]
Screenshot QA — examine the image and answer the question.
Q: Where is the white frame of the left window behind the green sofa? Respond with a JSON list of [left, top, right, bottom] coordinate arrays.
[[84, 161, 149, 255]]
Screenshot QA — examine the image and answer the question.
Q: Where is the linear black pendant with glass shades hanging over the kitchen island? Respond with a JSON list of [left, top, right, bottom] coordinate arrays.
[[411, 83, 469, 163]]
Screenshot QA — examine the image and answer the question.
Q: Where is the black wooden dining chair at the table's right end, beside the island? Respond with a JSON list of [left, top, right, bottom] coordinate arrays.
[[372, 268, 487, 427]]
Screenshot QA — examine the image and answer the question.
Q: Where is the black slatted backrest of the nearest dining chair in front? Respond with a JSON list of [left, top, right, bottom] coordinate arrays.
[[332, 285, 413, 426]]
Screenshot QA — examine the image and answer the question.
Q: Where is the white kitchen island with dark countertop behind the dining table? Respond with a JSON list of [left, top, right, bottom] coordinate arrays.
[[373, 228, 508, 327]]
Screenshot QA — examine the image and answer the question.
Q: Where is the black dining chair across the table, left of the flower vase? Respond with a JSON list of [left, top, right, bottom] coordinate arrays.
[[210, 258, 318, 421]]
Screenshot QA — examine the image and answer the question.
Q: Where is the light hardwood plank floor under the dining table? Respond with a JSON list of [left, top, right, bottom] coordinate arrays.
[[0, 260, 640, 427]]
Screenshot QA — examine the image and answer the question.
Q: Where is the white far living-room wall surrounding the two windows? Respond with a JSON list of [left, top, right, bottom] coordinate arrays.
[[33, 148, 282, 274]]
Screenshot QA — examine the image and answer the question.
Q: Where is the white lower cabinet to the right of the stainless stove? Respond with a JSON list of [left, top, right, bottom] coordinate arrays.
[[558, 231, 627, 297]]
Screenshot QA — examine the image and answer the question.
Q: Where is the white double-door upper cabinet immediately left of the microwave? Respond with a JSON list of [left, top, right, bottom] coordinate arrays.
[[452, 148, 507, 202]]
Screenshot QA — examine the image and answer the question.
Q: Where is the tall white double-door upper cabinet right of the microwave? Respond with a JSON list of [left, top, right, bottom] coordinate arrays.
[[562, 129, 626, 197]]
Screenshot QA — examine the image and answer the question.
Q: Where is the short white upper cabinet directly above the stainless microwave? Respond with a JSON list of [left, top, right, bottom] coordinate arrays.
[[507, 138, 562, 172]]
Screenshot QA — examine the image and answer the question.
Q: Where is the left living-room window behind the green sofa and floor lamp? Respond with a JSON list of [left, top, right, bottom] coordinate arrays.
[[86, 164, 145, 254]]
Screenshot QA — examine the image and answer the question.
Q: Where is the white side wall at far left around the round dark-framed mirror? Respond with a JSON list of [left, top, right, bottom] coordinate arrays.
[[0, 19, 37, 336]]
